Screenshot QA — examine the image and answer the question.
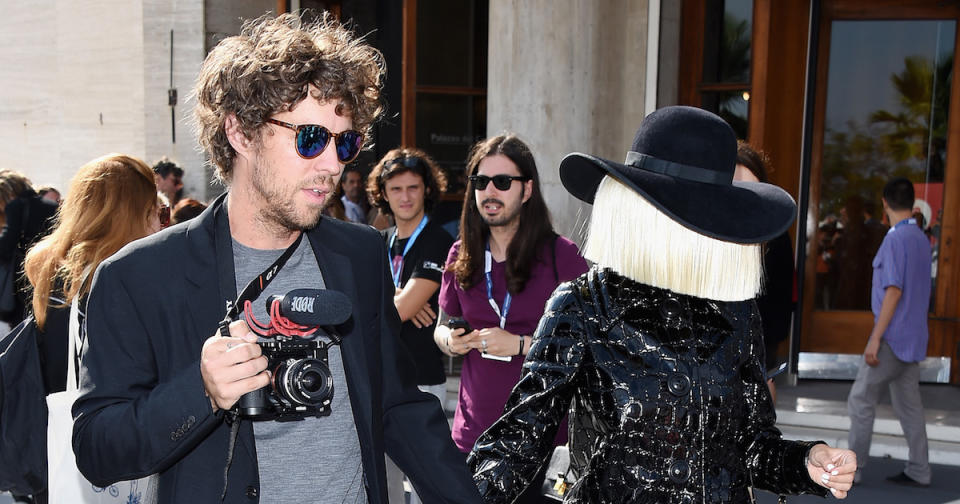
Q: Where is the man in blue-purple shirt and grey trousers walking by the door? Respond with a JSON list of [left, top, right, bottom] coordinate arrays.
[[847, 178, 930, 486]]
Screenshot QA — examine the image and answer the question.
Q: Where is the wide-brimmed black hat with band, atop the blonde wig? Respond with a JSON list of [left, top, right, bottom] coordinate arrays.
[[560, 106, 797, 243]]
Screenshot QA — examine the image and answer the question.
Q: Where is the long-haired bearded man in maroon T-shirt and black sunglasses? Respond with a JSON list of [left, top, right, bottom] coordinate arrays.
[[434, 135, 587, 503]]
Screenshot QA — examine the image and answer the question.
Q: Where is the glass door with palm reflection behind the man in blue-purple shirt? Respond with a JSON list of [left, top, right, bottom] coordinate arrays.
[[800, 1, 960, 382]]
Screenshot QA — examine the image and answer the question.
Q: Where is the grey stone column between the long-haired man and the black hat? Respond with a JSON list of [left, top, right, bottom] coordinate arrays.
[[487, 0, 647, 243]]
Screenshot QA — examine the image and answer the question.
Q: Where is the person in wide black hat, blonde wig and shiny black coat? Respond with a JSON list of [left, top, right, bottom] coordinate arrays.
[[469, 107, 856, 503]]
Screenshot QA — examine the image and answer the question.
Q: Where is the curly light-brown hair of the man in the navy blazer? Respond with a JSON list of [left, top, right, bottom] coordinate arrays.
[[193, 12, 386, 183]]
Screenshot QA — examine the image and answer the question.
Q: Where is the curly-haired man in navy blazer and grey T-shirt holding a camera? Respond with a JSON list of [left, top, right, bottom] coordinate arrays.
[[73, 11, 479, 504]]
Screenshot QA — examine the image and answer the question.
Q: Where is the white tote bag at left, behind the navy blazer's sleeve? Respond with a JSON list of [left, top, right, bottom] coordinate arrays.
[[47, 296, 157, 504]]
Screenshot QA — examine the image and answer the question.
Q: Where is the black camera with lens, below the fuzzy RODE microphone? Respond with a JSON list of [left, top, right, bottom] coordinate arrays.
[[237, 337, 333, 421]]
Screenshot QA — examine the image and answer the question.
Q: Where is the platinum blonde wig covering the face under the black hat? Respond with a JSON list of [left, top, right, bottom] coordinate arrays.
[[583, 176, 763, 301]]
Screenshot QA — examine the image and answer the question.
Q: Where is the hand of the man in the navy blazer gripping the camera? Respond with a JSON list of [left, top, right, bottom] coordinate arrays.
[[200, 320, 270, 411]]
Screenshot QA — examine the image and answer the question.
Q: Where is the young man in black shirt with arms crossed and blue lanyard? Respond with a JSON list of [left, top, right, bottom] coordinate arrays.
[[367, 148, 453, 504]]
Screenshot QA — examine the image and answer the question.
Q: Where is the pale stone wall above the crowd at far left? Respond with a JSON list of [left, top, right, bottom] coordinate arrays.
[[0, 0, 207, 201]]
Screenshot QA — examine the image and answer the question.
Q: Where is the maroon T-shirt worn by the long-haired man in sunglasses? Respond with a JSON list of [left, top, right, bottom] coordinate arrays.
[[440, 236, 587, 452]]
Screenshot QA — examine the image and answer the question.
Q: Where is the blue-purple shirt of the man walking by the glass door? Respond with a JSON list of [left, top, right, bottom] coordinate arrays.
[[870, 219, 931, 362]]
